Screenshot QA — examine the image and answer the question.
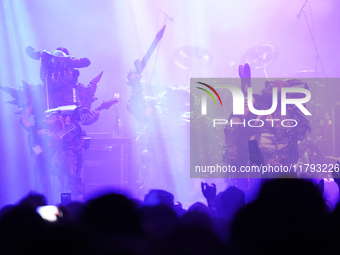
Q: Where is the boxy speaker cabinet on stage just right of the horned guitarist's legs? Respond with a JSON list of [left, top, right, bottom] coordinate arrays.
[[83, 137, 132, 192]]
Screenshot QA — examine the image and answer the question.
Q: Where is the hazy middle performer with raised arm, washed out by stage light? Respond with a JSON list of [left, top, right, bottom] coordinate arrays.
[[127, 69, 192, 201]]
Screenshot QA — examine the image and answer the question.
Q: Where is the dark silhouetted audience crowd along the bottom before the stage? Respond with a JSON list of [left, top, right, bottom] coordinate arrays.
[[0, 173, 340, 255]]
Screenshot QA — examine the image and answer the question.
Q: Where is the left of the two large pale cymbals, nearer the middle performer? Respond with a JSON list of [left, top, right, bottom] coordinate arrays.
[[174, 45, 214, 70]]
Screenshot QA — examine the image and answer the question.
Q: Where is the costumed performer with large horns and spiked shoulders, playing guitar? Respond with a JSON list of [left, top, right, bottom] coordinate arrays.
[[2, 47, 102, 199]]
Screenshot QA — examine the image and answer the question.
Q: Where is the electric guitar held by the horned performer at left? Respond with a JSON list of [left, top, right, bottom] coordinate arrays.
[[28, 99, 118, 161]]
